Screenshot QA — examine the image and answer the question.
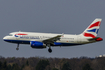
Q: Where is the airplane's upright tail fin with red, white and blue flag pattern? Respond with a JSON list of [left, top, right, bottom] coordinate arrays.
[[82, 18, 102, 38]]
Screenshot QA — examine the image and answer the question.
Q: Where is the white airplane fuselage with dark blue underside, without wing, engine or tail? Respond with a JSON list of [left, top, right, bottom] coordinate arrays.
[[3, 32, 90, 46]]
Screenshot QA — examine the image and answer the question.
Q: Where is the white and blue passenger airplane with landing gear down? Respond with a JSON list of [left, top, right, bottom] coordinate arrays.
[[3, 18, 103, 53]]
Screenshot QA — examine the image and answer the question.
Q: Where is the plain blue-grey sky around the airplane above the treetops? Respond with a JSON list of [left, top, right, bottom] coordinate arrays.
[[0, 0, 105, 58]]
